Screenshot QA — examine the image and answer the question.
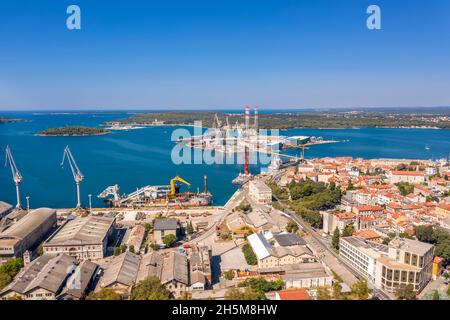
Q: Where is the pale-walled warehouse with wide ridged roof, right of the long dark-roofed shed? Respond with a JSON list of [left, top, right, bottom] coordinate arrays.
[[43, 216, 114, 260]]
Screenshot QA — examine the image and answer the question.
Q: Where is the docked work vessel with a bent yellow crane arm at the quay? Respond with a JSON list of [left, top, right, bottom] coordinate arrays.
[[98, 176, 212, 208]]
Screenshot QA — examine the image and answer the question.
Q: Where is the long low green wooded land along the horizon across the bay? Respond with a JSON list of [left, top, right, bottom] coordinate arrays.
[[103, 110, 450, 129]]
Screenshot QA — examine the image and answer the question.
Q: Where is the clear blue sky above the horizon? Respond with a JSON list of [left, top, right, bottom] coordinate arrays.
[[0, 0, 450, 110]]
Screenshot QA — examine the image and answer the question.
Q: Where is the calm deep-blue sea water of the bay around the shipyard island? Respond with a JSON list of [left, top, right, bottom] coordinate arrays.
[[0, 113, 450, 207]]
